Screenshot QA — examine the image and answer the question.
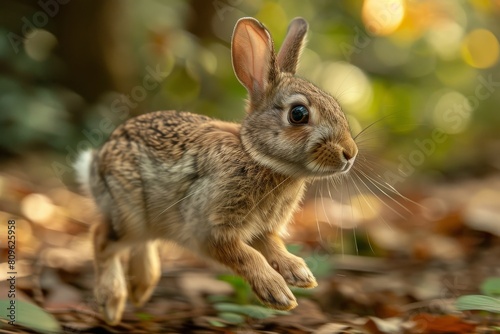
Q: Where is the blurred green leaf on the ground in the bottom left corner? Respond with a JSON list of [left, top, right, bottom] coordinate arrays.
[[0, 300, 61, 333]]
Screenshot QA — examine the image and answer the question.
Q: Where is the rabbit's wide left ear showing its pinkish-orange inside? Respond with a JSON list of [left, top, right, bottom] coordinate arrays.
[[231, 17, 277, 100]]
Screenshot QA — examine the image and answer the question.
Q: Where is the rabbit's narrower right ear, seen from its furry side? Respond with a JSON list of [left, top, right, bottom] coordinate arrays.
[[278, 17, 307, 74]]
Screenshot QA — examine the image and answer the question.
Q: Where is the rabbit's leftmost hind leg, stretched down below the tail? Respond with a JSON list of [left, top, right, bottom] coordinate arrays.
[[93, 221, 127, 325]]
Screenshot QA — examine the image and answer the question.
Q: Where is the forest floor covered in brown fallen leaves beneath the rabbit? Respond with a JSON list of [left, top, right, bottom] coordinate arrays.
[[0, 156, 500, 334]]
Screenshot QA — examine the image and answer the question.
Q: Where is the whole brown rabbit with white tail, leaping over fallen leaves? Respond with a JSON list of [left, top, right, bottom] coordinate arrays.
[[76, 17, 358, 325]]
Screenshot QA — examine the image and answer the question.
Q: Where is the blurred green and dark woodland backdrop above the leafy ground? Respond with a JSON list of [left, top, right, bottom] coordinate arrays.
[[0, 0, 500, 176]]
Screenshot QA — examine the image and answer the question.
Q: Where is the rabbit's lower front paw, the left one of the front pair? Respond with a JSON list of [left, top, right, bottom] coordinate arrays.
[[251, 272, 297, 311]]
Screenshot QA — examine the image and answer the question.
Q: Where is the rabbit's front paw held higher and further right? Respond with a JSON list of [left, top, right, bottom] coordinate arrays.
[[271, 254, 318, 288]]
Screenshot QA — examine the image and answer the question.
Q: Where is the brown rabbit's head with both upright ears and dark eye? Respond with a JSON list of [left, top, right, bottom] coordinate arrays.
[[231, 18, 358, 180]]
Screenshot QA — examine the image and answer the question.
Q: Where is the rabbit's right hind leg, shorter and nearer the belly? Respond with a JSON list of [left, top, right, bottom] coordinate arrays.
[[128, 241, 161, 306]]
